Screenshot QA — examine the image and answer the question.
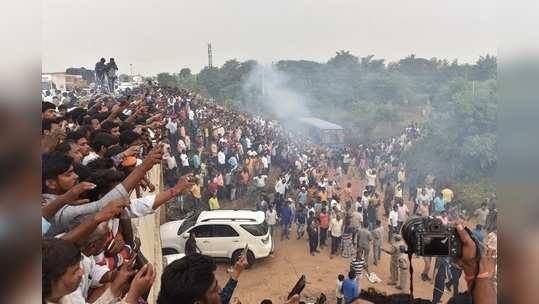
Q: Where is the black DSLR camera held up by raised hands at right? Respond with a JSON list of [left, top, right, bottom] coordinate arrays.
[[401, 217, 462, 258]]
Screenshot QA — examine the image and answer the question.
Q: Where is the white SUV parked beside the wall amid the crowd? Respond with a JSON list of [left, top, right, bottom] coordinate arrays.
[[160, 210, 274, 266]]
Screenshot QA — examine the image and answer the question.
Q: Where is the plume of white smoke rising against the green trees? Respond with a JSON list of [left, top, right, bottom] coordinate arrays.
[[242, 64, 309, 119]]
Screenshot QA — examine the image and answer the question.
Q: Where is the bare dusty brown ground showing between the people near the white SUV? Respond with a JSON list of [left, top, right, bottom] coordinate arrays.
[[211, 173, 465, 304]]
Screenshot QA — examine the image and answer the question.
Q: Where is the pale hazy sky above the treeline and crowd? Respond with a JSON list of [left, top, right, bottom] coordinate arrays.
[[42, 0, 497, 75]]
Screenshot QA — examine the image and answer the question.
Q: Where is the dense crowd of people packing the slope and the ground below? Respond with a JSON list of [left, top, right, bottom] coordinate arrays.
[[41, 72, 496, 304]]
